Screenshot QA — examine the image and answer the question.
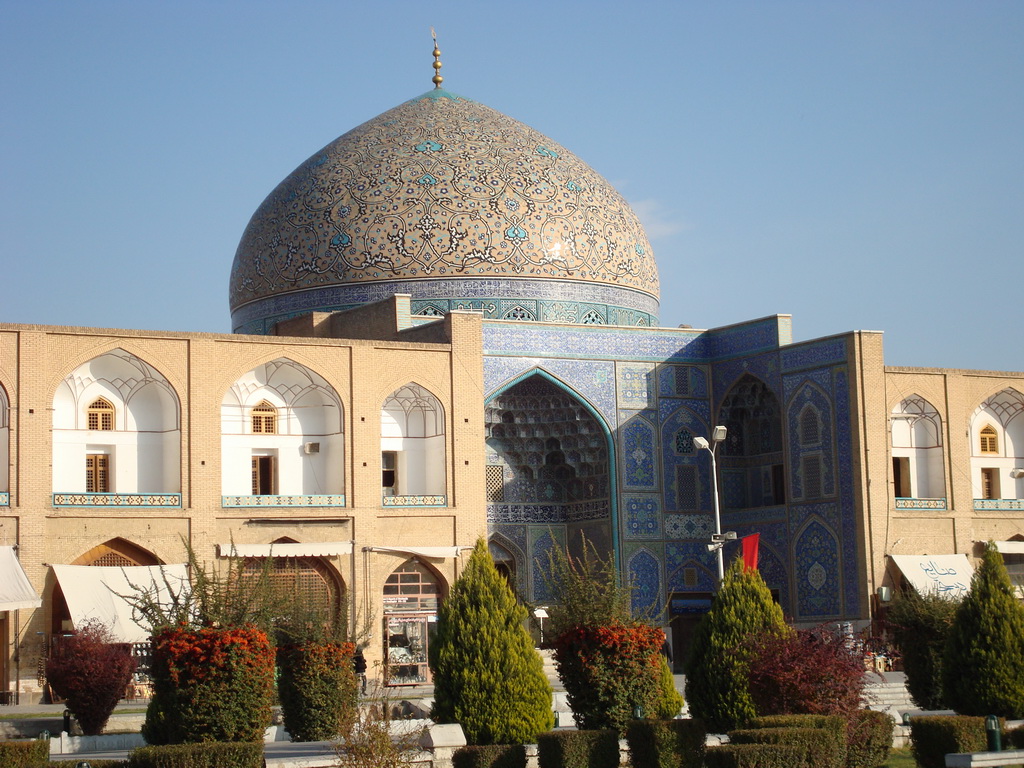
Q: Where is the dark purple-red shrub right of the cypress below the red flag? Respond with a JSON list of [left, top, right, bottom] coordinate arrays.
[[749, 627, 864, 719]]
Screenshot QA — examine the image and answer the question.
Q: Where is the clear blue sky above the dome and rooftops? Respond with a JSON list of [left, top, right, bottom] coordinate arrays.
[[0, 0, 1024, 371]]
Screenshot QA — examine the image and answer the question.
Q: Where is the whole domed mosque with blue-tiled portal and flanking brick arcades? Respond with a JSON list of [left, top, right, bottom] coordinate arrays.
[[0, 45, 1024, 702]]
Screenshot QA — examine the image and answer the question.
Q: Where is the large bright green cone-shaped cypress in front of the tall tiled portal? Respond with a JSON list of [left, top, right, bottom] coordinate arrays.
[[430, 539, 554, 744]]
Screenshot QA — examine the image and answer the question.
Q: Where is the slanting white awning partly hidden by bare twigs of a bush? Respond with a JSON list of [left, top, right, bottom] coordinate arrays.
[[52, 563, 188, 643]]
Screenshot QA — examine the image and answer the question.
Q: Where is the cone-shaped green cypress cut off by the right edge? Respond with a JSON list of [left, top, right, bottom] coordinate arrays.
[[942, 542, 1024, 719]]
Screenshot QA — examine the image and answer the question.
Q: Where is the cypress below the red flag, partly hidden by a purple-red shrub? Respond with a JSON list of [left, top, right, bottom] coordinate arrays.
[[685, 558, 790, 733]]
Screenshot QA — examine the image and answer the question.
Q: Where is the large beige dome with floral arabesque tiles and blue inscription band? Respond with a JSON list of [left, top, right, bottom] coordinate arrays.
[[230, 88, 658, 333]]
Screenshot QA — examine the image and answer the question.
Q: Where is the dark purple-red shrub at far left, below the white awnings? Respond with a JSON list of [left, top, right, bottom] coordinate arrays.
[[46, 622, 135, 736]]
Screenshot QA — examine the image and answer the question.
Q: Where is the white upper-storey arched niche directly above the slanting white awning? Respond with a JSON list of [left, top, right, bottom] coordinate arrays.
[[52, 349, 181, 495]]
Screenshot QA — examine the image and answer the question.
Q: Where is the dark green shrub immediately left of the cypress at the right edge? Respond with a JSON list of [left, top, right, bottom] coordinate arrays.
[[886, 590, 961, 710]]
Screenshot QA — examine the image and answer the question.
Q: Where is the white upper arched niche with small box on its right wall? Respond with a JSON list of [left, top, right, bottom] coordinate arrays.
[[220, 357, 345, 499]]
